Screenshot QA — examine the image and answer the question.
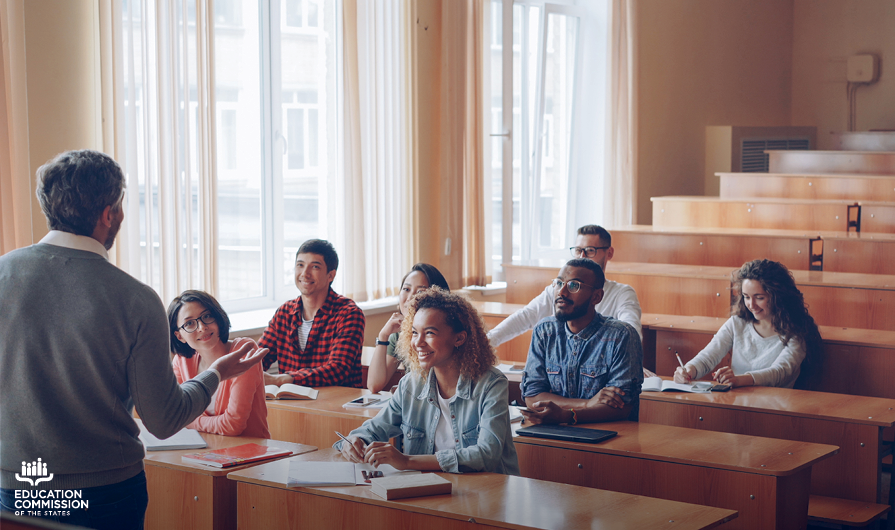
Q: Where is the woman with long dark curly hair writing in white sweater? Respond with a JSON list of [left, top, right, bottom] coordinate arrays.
[[674, 259, 821, 388]]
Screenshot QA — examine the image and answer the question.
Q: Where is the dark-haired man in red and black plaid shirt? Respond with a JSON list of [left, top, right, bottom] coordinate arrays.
[[258, 239, 364, 387]]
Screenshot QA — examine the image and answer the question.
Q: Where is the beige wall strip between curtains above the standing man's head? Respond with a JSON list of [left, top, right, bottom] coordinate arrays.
[[25, 0, 102, 242]]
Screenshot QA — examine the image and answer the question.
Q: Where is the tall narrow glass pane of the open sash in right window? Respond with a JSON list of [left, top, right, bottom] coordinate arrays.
[[534, 13, 578, 250]]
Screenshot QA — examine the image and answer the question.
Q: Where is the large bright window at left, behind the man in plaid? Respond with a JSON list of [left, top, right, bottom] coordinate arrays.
[[122, 0, 341, 310]]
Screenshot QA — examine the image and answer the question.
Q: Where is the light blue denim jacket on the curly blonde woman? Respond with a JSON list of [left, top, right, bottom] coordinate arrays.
[[333, 367, 519, 475]]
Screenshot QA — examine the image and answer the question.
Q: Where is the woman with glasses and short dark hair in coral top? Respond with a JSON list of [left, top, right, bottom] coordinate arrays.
[[168, 290, 270, 438]]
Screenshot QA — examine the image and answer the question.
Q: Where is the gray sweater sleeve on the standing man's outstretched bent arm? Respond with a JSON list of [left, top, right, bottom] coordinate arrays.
[[126, 287, 219, 438]]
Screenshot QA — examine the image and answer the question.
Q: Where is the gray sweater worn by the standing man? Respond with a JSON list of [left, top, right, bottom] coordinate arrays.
[[0, 243, 218, 489]]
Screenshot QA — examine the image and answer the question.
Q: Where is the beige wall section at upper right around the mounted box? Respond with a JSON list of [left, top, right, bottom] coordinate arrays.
[[792, 0, 895, 149]]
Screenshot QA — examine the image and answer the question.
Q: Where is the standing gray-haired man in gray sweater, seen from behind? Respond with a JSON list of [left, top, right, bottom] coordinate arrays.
[[0, 151, 267, 529]]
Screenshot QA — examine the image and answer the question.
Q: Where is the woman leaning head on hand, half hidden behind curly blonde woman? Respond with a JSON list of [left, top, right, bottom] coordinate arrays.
[[367, 263, 451, 393]]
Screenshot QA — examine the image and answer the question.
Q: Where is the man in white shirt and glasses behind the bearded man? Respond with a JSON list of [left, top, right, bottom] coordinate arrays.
[[488, 225, 643, 348]]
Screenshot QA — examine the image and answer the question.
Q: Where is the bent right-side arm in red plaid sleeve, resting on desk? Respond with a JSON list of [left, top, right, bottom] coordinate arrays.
[[288, 307, 364, 387]]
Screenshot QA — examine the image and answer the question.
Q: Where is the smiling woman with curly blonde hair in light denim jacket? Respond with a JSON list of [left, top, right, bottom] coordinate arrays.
[[334, 287, 519, 475]]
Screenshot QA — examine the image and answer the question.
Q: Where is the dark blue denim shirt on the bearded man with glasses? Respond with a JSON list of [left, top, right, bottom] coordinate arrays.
[[522, 313, 643, 421]]
